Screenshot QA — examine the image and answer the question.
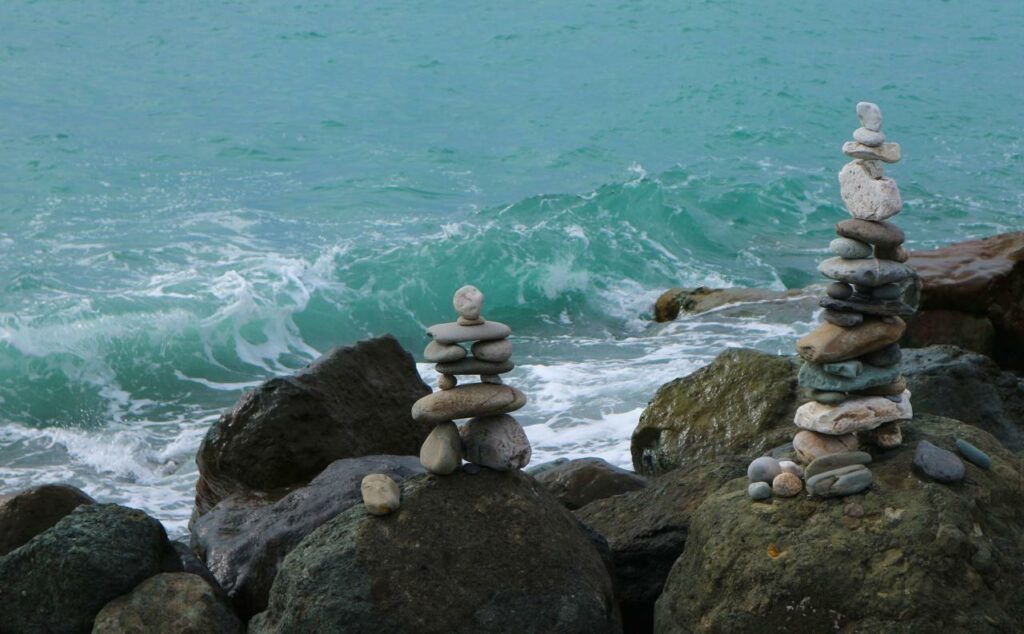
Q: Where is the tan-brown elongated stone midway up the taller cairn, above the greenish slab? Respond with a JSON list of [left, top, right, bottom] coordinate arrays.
[[797, 318, 906, 364]]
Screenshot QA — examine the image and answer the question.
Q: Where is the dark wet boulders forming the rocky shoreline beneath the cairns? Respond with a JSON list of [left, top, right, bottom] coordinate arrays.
[[0, 242, 1024, 633]]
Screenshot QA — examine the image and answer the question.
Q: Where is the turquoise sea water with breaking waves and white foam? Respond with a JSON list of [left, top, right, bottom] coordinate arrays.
[[0, 0, 1024, 532]]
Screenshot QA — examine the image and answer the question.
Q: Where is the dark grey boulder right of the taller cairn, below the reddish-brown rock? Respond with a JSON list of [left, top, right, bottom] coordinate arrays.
[[900, 345, 1024, 451]]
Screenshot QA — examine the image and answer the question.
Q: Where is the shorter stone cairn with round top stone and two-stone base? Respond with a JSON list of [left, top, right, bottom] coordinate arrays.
[[413, 286, 531, 475]]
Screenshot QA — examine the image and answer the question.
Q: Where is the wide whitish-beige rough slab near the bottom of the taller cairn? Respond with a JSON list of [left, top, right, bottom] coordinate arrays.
[[793, 390, 913, 435]]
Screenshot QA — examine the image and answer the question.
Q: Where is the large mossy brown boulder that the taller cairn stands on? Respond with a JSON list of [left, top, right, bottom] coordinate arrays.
[[654, 415, 1024, 634]]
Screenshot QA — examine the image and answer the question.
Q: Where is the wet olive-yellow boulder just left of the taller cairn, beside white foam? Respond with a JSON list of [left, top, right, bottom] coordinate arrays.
[[631, 348, 799, 474]]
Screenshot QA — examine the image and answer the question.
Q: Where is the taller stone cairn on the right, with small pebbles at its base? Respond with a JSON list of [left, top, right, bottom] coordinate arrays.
[[748, 101, 914, 499]]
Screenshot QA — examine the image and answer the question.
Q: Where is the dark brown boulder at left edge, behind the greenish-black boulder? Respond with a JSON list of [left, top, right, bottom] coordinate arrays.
[[0, 484, 95, 555]]
